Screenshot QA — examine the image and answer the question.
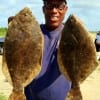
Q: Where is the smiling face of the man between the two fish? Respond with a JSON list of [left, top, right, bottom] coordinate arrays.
[[43, 1, 67, 30]]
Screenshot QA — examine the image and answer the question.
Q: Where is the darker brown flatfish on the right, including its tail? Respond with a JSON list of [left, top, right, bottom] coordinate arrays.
[[58, 15, 97, 100]]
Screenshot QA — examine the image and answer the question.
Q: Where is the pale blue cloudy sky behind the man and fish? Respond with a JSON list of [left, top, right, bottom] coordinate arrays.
[[0, 0, 100, 31]]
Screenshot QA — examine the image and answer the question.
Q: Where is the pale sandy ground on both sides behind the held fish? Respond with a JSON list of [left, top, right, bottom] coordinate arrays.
[[0, 56, 100, 100]]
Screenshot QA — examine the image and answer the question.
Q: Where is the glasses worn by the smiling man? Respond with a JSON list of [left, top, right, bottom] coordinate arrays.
[[44, 2, 66, 10]]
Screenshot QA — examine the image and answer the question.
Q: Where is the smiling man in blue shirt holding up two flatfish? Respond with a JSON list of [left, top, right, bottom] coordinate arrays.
[[25, 0, 71, 100]]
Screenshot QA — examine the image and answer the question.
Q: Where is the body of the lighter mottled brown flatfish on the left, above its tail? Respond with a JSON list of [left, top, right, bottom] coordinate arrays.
[[3, 7, 43, 100]]
